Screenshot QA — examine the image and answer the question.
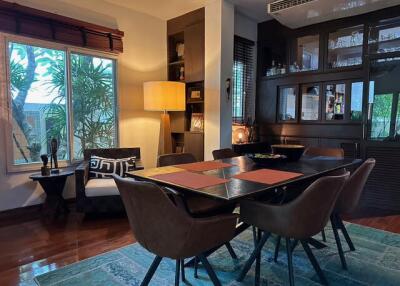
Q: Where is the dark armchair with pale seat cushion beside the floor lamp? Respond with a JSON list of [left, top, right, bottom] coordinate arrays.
[[75, 147, 143, 213]]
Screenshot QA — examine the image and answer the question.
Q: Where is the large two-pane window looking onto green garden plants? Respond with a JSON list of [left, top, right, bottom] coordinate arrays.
[[7, 41, 116, 165]]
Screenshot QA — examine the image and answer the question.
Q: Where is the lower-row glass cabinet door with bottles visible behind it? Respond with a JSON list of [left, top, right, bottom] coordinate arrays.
[[325, 83, 346, 121]]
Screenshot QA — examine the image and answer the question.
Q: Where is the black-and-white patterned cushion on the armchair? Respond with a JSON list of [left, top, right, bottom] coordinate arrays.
[[89, 156, 136, 178]]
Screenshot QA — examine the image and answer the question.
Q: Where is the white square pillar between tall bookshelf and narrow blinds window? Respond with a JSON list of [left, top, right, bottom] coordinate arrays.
[[204, 0, 235, 160]]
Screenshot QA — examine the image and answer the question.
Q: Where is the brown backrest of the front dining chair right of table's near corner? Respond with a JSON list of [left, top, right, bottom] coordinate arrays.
[[284, 172, 350, 239]]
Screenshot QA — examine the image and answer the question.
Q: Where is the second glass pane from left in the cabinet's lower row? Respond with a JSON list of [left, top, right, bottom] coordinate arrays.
[[301, 85, 320, 121]]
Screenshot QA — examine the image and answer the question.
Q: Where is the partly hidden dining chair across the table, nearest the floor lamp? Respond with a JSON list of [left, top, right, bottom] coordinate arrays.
[[157, 153, 237, 278]]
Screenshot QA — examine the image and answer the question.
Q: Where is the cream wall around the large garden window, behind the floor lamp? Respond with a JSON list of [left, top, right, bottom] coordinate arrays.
[[0, 0, 167, 211]]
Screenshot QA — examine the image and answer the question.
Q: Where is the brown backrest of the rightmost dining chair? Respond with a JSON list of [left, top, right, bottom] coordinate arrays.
[[335, 158, 376, 214]]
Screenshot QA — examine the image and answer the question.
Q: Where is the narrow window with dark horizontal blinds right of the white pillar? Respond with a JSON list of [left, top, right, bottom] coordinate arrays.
[[232, 36, 254, 123]]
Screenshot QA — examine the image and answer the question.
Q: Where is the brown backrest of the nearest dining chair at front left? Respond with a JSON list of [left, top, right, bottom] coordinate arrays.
[[114, 176, 192, 257]]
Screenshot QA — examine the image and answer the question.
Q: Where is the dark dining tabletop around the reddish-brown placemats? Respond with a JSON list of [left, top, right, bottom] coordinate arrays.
[[126, 156, 362, 201]]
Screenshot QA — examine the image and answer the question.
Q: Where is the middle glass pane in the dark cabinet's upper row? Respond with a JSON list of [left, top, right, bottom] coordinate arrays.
[[327, 25, 364, 69]]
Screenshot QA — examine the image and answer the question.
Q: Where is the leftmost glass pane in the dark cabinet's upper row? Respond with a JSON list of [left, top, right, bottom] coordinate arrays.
[[289, 34, 319, 72]]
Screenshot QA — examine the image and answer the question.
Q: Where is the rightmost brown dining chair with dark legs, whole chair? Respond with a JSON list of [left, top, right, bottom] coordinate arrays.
[[331, 158, 376, 269]]
